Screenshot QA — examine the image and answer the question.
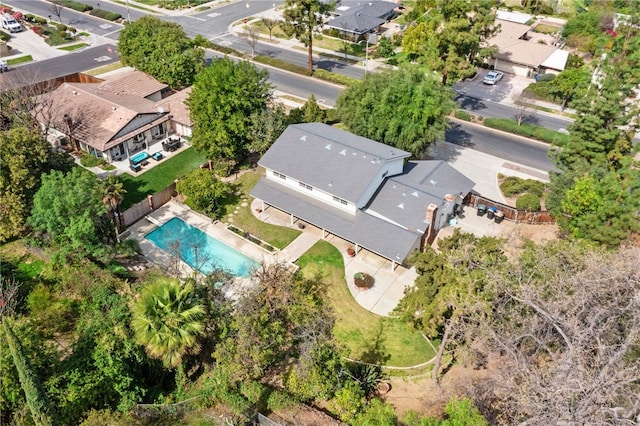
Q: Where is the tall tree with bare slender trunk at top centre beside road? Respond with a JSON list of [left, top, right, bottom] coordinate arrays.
[[281, 0, 335, 72]]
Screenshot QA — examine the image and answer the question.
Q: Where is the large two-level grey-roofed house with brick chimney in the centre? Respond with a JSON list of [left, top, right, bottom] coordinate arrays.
[[251, 123, 474, 268]]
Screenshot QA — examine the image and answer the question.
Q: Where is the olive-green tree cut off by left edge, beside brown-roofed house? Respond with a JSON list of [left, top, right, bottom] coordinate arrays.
[[0, 127, 51, 242]]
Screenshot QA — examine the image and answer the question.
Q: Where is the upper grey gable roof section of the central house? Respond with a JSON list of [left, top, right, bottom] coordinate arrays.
[[258, 123, 411, 203]]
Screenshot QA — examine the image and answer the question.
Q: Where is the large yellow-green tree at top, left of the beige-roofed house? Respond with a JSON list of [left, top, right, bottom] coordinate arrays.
[[402, 0, 498, 84]]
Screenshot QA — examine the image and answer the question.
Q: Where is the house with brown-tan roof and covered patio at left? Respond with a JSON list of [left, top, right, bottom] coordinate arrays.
[[38, 71, 188, 161]]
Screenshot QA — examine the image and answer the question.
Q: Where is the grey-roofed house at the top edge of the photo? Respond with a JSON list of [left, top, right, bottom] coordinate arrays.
[[325, 0, 398, 41]]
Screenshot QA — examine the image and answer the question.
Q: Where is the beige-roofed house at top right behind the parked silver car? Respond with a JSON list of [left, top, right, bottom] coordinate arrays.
[[487, 17, 569, 77]]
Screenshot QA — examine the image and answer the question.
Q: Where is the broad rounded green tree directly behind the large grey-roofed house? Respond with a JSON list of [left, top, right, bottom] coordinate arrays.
[[337, 66, 455, 156]]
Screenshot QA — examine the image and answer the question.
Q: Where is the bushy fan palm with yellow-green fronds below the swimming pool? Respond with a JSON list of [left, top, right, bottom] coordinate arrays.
[[131, 278, 205, 368]]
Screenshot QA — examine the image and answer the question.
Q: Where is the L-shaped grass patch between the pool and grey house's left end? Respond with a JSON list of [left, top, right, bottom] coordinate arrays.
[[222, 170, 300, 249]]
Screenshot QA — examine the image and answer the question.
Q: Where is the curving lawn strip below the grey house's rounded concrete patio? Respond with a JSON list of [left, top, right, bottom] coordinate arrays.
[[298, 241, 435, 367]]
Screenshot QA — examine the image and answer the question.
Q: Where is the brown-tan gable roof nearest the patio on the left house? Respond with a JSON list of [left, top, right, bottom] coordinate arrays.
[[45, 83, 168, 151]]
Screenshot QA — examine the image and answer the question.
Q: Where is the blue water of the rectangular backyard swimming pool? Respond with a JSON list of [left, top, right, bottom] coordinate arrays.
[[145, 217, 258, 277]]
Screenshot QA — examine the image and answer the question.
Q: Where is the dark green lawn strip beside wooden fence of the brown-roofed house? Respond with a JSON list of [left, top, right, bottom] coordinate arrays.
[[120, 148, 206, 210]]
